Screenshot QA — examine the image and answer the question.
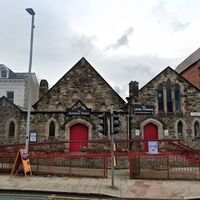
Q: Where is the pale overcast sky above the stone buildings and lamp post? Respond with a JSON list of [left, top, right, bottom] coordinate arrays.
[[0, 0, 200, 98]]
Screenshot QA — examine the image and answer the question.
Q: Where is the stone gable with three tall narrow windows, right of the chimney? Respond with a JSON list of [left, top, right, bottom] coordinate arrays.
[[132, 67, 200, 113]]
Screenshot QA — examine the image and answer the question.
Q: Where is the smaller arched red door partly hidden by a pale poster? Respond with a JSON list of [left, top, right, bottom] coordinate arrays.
[[144, 123, 158, 152]]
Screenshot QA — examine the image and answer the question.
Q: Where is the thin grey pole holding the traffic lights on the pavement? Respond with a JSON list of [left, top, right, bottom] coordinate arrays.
[[110, 106, 115, 189]]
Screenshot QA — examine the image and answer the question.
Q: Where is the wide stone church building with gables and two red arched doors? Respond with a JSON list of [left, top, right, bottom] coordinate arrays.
[[0, 58, 200, 152]]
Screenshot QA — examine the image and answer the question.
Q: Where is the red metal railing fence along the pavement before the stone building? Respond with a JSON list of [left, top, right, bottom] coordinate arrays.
[[0, 140, 200, 180]]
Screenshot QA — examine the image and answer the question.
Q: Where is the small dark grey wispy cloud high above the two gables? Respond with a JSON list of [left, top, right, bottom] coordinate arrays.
[[106, 27, 134, 50]]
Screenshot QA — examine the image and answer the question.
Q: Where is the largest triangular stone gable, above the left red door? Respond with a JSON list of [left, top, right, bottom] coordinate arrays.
[[33, 58, 125, 111]]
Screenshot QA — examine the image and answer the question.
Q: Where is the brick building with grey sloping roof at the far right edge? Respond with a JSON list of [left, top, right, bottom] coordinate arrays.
[[175, 48, 200, 89]]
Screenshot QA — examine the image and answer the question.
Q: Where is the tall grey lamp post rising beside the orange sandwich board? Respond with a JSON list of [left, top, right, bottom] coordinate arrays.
[[25, 8, 35, 153]]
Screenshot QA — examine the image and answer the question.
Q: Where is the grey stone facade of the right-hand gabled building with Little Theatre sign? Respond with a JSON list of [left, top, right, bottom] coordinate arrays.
[[127, 67, 200, 149]]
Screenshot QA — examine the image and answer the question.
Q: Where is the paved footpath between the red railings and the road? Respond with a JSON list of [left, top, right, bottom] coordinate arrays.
[[0, 174, 200, 199]]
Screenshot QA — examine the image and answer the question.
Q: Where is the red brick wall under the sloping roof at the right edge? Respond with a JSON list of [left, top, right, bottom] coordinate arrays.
[[181, 62, 200, 89]]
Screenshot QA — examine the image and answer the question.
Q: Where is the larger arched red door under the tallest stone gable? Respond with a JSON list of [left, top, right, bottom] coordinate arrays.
[[69, 124, 88, 152]]
